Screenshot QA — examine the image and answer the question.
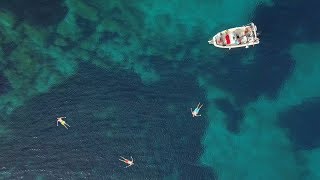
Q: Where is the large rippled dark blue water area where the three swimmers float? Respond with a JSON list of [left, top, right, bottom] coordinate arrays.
[[1, 64, 213, 179]]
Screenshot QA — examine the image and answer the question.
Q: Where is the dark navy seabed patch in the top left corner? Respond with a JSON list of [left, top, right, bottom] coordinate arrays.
[[0, 0, 68, 27]]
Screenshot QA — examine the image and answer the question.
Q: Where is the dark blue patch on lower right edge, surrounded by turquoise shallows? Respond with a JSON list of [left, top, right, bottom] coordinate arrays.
[[279, 98, 320, 150]]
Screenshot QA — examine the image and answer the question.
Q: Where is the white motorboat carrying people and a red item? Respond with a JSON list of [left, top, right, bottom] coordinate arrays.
[[208, 23, 259, 49]]
